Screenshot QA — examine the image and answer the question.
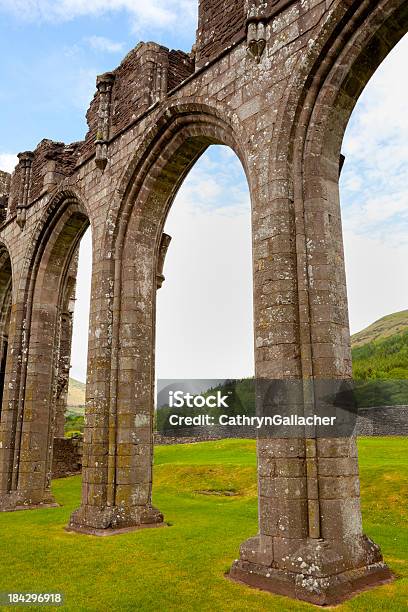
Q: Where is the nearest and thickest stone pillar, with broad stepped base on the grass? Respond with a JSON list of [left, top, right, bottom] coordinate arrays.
[[231, 157, 391, 605]]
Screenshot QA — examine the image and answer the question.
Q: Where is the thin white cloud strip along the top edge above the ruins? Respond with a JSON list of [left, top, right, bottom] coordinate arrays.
[[0, 0, 197, 30]]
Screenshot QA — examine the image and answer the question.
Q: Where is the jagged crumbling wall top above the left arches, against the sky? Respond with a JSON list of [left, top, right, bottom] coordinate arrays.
[[0, 42, 194, 215]]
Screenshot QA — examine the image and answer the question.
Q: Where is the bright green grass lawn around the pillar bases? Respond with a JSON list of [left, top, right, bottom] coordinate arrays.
[[0, 438, 408, 612]]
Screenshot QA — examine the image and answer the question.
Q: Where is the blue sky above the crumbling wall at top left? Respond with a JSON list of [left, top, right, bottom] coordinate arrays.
[[0, 0, 196, 153]]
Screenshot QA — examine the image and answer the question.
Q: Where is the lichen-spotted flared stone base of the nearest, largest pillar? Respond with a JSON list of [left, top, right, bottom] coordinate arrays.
[[229, 536, 394, 606]]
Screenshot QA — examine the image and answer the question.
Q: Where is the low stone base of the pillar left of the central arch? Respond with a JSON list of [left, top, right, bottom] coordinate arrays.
[[66, 506, 165, 536]]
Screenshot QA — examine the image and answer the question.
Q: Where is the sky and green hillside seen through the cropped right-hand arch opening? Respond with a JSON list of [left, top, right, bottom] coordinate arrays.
[[339, 35, 408, 440]]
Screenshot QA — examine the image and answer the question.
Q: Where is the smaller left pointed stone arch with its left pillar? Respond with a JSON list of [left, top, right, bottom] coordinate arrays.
[[3, 192, 89, 507]]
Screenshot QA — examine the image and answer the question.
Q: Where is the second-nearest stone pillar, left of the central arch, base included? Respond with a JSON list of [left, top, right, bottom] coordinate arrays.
[[68, 240, 164, 535]]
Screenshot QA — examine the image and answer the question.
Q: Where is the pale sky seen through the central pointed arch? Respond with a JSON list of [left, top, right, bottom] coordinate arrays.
[[156, 145, 254, 379]]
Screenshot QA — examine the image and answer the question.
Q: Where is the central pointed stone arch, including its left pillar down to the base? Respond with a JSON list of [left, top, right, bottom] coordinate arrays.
[[70, 104, 250, 533]]
